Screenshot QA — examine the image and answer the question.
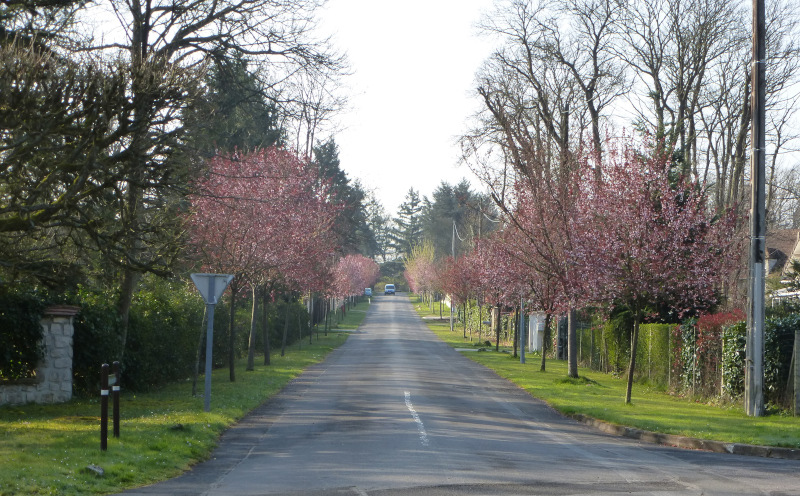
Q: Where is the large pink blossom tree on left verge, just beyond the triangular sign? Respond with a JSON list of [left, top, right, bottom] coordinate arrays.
[[188, 147, 336, 381]]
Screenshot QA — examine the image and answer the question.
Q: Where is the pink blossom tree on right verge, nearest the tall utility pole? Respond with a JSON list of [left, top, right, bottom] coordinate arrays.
[[571, 143, 736, 403]]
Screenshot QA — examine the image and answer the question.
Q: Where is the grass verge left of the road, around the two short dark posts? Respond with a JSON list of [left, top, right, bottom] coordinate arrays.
[[0, 303, 369, 496]]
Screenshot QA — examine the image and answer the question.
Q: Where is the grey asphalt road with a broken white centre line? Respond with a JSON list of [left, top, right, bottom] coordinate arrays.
[[119, 294, 800, 496]]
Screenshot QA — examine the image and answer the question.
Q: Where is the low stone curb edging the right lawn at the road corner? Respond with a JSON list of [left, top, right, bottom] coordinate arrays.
[[568, 414, 800, 460]]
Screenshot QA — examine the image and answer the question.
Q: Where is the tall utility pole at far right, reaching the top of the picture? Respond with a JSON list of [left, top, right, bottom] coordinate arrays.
[[744, 0, 766, 417]]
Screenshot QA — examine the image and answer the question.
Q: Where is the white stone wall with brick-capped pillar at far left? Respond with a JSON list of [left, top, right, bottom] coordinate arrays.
[[0, 307, 77, 405]]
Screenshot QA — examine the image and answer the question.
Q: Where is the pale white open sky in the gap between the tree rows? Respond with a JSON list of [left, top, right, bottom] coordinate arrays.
[[319, 0, 493, 216]]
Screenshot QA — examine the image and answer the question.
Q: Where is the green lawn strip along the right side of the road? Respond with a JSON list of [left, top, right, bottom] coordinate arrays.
[[412, 299, 800, 448]]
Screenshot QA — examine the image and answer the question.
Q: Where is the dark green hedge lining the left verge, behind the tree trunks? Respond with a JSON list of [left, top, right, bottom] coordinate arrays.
[[73, 277, 308, 395]]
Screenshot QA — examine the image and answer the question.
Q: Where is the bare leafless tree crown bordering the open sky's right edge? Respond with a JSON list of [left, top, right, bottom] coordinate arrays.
[[472, 1, 586, 180]]
